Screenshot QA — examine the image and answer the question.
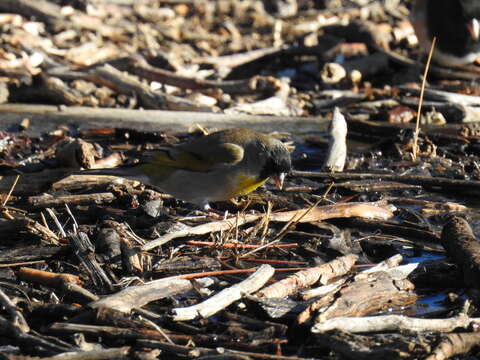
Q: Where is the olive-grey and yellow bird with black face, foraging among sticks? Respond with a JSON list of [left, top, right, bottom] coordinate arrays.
[[79, 128, 292, 210]]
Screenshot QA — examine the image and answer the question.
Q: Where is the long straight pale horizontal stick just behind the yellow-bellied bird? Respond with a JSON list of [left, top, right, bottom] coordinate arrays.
[[0, 104, 328, 135]]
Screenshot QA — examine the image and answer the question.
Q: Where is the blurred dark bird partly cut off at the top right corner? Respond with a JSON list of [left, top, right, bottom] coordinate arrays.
[[411, 0, 480, 67]]
